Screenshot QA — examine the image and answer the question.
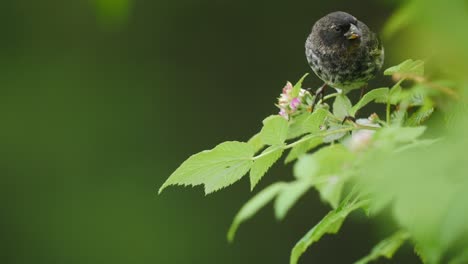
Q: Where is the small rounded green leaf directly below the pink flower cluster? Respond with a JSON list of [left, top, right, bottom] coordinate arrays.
[[260, 115, 288, 145]]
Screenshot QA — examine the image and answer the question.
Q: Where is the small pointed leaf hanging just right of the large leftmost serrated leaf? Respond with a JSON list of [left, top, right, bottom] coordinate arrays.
[[250, 145, 283, 190]]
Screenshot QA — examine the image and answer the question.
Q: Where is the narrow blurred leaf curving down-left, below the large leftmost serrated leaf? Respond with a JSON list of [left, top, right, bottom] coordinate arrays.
[[227, 182, 286, 242]]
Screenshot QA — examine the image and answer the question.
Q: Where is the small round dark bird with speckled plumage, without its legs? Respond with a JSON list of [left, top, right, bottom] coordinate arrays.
[[305, 12, 384, 93]]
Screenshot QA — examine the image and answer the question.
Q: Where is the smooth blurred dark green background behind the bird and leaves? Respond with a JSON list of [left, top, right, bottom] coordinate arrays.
[[0, 0, 462, 264]]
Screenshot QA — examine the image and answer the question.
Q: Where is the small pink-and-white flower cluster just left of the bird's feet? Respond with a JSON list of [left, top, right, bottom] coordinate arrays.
[[277, 82, 312, 120]]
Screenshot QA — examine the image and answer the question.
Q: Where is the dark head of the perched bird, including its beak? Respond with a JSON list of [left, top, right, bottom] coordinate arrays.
[[313, 12, 363, 45]]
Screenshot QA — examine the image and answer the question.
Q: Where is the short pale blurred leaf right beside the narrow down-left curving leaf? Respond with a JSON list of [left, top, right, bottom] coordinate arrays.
[[274, 180, 312, 220]]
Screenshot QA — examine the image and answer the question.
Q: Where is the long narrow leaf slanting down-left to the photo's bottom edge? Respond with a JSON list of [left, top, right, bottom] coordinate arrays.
[[289, 197, 367, 264]]
